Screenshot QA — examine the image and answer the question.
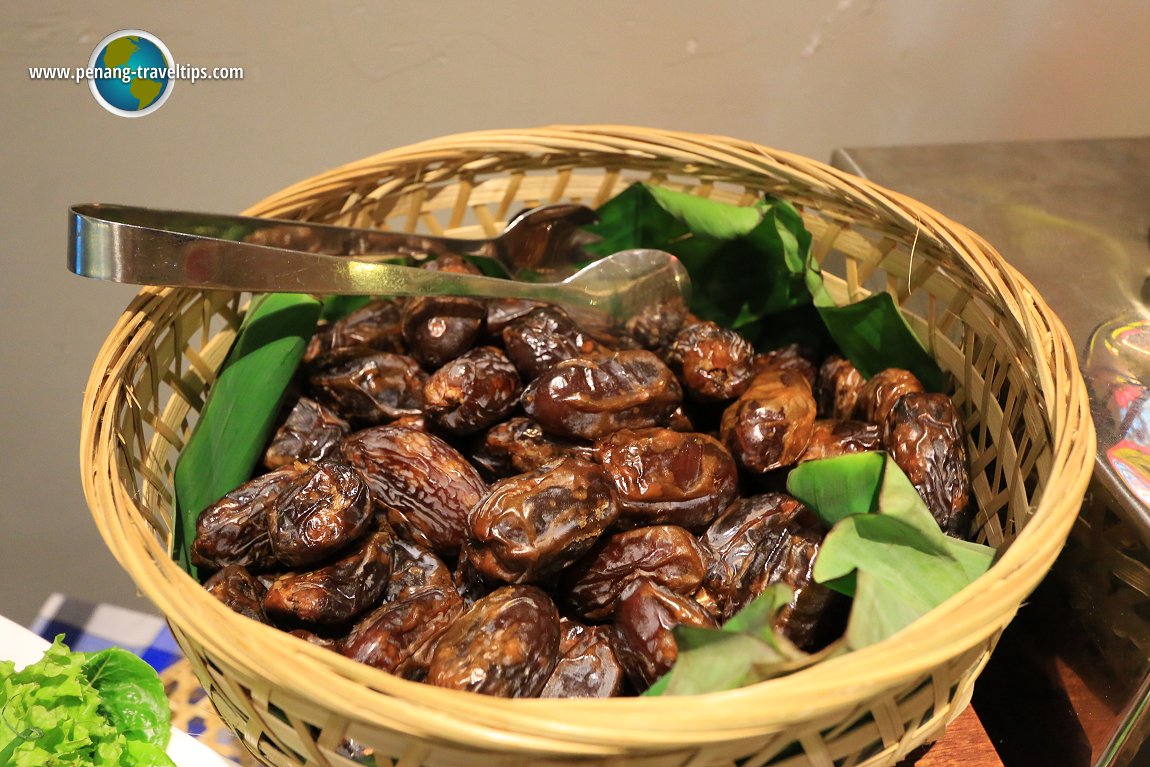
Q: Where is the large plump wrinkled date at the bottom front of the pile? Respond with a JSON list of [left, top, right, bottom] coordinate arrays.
[[427, 585, 559, 698]]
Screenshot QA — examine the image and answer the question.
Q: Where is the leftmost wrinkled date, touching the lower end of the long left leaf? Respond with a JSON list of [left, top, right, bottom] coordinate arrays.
[[192, 466, 300, 570]]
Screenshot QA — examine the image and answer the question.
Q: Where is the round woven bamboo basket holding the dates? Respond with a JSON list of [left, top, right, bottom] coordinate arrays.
[[82, 125, 1095, 767]]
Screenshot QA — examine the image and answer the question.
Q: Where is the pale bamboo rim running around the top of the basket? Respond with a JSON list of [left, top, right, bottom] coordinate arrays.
[[82, 125, 1095, 752]]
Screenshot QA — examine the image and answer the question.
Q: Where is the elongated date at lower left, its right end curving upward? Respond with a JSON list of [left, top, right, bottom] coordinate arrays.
[[263, 531, 392, 626]]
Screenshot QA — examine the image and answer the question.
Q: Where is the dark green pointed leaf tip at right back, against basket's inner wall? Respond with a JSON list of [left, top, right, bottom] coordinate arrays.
[[819, 293, 946, 391]]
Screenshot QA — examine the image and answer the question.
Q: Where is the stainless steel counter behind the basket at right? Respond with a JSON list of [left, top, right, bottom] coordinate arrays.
[[831, 138, 1150, 767]]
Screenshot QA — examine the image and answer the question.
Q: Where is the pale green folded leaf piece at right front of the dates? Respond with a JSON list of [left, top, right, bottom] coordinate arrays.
[[814, 459, 995, 650]]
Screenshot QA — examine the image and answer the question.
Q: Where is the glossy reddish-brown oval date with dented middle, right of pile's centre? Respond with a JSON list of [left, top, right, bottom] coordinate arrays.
[[597, 428, 738, 530]]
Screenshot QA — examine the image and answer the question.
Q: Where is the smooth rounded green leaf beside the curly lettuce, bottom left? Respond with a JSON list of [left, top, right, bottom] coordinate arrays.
[[84, 647, 171, 751]]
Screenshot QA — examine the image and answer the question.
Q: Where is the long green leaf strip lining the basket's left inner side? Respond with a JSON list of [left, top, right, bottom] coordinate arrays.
[[173, 293, 321, 576]]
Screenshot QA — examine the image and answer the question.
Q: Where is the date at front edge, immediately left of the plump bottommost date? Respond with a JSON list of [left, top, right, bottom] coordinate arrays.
[[339, 588, 463, 678]]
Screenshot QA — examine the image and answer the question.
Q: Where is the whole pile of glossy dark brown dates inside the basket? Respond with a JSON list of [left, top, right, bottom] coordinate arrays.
[[192, 256, 972, 697]]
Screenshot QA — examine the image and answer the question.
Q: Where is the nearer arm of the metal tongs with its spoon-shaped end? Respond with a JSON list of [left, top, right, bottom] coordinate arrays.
[[68, 206, 690, 329]]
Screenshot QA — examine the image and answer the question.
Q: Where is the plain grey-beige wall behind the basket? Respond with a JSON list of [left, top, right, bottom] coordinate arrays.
[[0, 0, 1150, 622]]
